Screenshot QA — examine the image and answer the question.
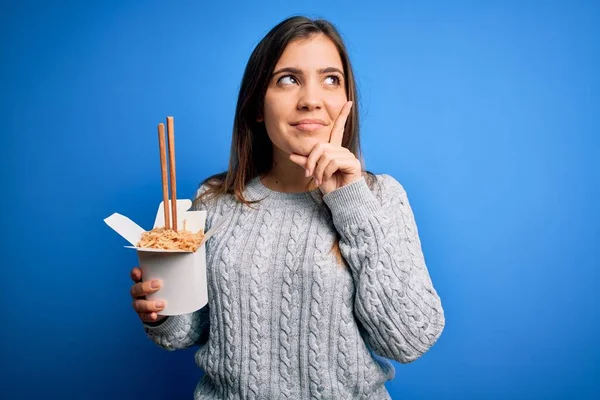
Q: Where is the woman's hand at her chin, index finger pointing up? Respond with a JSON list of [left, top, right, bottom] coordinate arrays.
[[290, 101, 362, 194]]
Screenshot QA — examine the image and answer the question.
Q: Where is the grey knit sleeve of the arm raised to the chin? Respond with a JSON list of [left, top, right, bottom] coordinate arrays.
[[323, 175, 445, 363]]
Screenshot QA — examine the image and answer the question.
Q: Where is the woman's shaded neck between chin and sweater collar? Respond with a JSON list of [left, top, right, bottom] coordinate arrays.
[[261, 149, 316, 193]]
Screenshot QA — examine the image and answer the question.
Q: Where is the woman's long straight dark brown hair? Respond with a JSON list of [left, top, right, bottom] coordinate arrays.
[[196, 16, 374, 205]]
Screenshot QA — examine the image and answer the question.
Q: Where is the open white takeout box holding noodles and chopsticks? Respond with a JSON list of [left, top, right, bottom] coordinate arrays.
[[104, 200, 208, 315]]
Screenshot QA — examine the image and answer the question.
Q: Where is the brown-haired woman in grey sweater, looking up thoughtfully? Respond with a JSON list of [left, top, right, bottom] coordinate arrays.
[[132, 17, 444, 399]]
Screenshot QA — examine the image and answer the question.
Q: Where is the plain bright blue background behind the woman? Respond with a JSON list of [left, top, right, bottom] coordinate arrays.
[[0, 1, 600, 400]]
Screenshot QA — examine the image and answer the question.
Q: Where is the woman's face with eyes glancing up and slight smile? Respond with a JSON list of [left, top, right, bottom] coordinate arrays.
[[263, 35, 347, 156]]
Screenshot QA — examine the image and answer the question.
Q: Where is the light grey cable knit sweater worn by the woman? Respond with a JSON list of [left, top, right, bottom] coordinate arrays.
[[144, 175, 444, 400]]
